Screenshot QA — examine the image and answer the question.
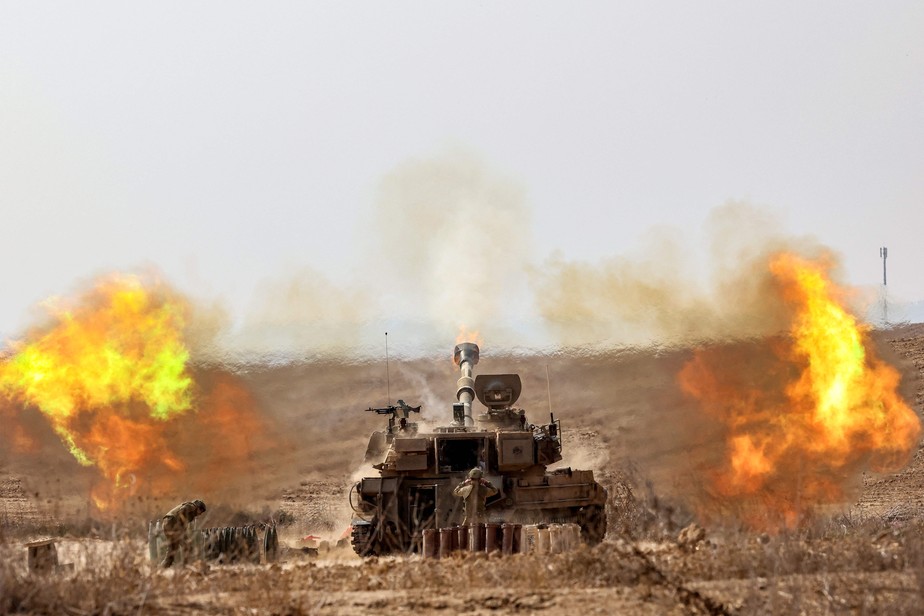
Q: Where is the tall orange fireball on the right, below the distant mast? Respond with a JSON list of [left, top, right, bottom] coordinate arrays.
[[679, 253, 921, 527]]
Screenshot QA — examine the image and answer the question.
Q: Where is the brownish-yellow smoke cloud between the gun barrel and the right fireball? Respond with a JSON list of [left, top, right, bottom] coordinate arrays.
[[531, 202, 825, 347]]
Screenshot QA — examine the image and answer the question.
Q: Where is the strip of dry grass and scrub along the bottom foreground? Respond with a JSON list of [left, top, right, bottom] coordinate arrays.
[[0, 521, 924, 614]]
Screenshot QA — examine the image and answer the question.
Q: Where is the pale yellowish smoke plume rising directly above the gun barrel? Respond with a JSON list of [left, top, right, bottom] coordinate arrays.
[[362, 150, 532, 344]]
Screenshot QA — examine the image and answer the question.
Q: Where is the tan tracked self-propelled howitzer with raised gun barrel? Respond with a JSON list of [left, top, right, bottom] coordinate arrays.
[[350, 342, 606, 556]]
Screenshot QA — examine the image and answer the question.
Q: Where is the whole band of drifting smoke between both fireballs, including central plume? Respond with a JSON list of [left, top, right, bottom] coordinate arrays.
[[192, 153, 844, 362]]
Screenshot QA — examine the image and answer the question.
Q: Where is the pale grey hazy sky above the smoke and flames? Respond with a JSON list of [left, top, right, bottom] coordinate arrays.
[[0, 0, 924, 352]]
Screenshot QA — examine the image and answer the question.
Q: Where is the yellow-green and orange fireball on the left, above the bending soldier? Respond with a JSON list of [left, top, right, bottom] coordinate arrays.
[[0, 276, 192, 504]]
